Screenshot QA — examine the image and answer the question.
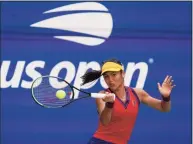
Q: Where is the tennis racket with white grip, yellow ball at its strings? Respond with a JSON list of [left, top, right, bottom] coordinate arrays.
[[31, 75, 114, 108]]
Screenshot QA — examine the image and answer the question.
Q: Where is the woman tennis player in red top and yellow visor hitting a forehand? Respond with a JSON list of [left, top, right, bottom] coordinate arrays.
[[82, 59, 175, 144]]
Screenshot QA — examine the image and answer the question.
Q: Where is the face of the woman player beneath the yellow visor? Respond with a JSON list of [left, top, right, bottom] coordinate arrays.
[[103, 71, 124, 91]]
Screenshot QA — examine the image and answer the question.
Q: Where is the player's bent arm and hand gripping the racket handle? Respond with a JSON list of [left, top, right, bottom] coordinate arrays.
[[96, 91, 114, 126]]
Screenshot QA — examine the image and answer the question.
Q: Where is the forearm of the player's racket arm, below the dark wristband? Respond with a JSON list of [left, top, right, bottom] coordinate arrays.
[[100, 105, 113, 125]]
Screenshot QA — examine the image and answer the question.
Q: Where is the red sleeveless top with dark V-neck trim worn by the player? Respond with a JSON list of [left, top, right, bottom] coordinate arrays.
[[93, 87, 140, 144]]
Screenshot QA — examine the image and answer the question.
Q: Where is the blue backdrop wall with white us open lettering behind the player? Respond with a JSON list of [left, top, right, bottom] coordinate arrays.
[[0, 2, 192, 144]]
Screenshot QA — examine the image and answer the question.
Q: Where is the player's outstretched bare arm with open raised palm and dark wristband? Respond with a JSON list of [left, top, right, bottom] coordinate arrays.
[[134, 76, 175, 112]]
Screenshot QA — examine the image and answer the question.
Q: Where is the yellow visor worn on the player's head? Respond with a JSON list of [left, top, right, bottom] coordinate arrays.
[[101, 62, 123, 74]]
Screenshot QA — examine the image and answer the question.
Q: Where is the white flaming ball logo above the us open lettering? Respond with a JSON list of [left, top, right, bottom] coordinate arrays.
[[30, 2, 113, 46]]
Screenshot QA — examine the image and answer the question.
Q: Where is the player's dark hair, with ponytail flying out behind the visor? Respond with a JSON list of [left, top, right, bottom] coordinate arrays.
[[81, 58, 122, 85]]
